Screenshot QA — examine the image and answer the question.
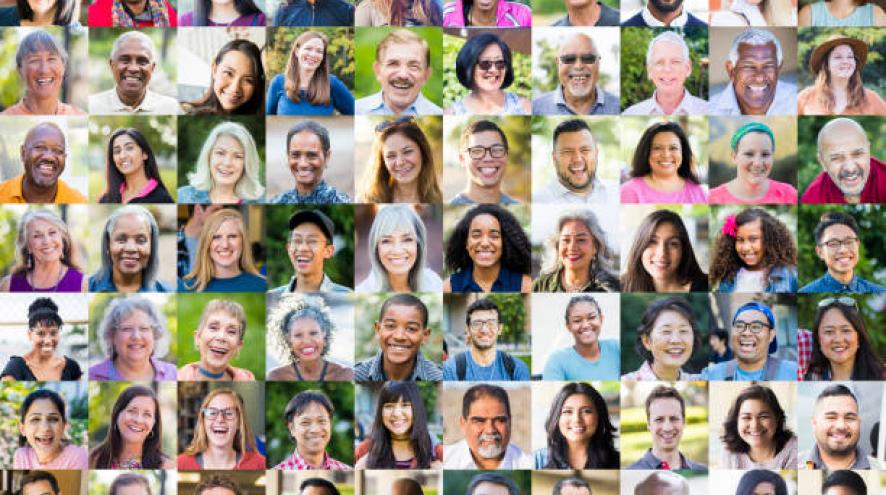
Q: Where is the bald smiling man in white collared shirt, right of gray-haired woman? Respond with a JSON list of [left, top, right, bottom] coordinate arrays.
[[89, 31, 180, 115]]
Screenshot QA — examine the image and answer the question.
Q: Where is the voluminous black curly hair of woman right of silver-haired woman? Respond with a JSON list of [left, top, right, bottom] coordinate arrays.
[[445, 204, 532, 274]]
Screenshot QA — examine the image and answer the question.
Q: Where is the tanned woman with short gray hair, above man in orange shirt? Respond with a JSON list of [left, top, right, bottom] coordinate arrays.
[[3, 30, 86, 115]]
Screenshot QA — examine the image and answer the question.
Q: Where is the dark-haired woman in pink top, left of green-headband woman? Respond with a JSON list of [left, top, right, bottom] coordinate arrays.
[[621, 122, 707, 203]]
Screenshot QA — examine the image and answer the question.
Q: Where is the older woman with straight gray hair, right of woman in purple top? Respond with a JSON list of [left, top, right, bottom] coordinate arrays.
[[89, 205, 172, 292]]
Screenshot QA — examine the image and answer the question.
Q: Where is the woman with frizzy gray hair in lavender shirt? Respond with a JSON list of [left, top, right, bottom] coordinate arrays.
[[89, 296, 176, 381]]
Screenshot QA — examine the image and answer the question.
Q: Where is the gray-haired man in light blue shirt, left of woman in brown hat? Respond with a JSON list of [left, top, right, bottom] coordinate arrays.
[[710, 28, 797, 115]]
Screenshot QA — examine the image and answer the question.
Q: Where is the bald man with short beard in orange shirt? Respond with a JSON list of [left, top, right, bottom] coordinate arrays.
[[0, 122, 86, 203]]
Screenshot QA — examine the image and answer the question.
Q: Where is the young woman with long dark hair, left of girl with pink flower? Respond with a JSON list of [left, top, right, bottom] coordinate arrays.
[[621, 210, 708, 292]]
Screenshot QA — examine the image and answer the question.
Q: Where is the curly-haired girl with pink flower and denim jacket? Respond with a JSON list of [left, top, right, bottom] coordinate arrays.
[[710, 208, 797, 292]]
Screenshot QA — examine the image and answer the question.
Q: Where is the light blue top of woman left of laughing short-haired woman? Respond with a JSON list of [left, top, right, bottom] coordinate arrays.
[[542, 340, 621, 380]]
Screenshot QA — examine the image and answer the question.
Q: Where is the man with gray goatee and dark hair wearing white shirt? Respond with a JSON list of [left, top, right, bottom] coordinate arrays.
[[443, 383, 532, 469]]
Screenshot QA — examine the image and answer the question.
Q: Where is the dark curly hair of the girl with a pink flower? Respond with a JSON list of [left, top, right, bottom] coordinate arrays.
[[710, 208, 797, 285]]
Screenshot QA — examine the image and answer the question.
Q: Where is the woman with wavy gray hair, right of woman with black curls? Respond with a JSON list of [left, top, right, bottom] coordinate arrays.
[[532, 210, 620, 292]]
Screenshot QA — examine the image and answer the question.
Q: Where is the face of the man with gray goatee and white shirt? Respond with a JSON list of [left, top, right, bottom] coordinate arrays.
[[459, 395, 511, 459]]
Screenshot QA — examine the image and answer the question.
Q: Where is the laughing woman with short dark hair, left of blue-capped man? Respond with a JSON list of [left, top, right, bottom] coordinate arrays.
[[622, 296, 701, 381]]
